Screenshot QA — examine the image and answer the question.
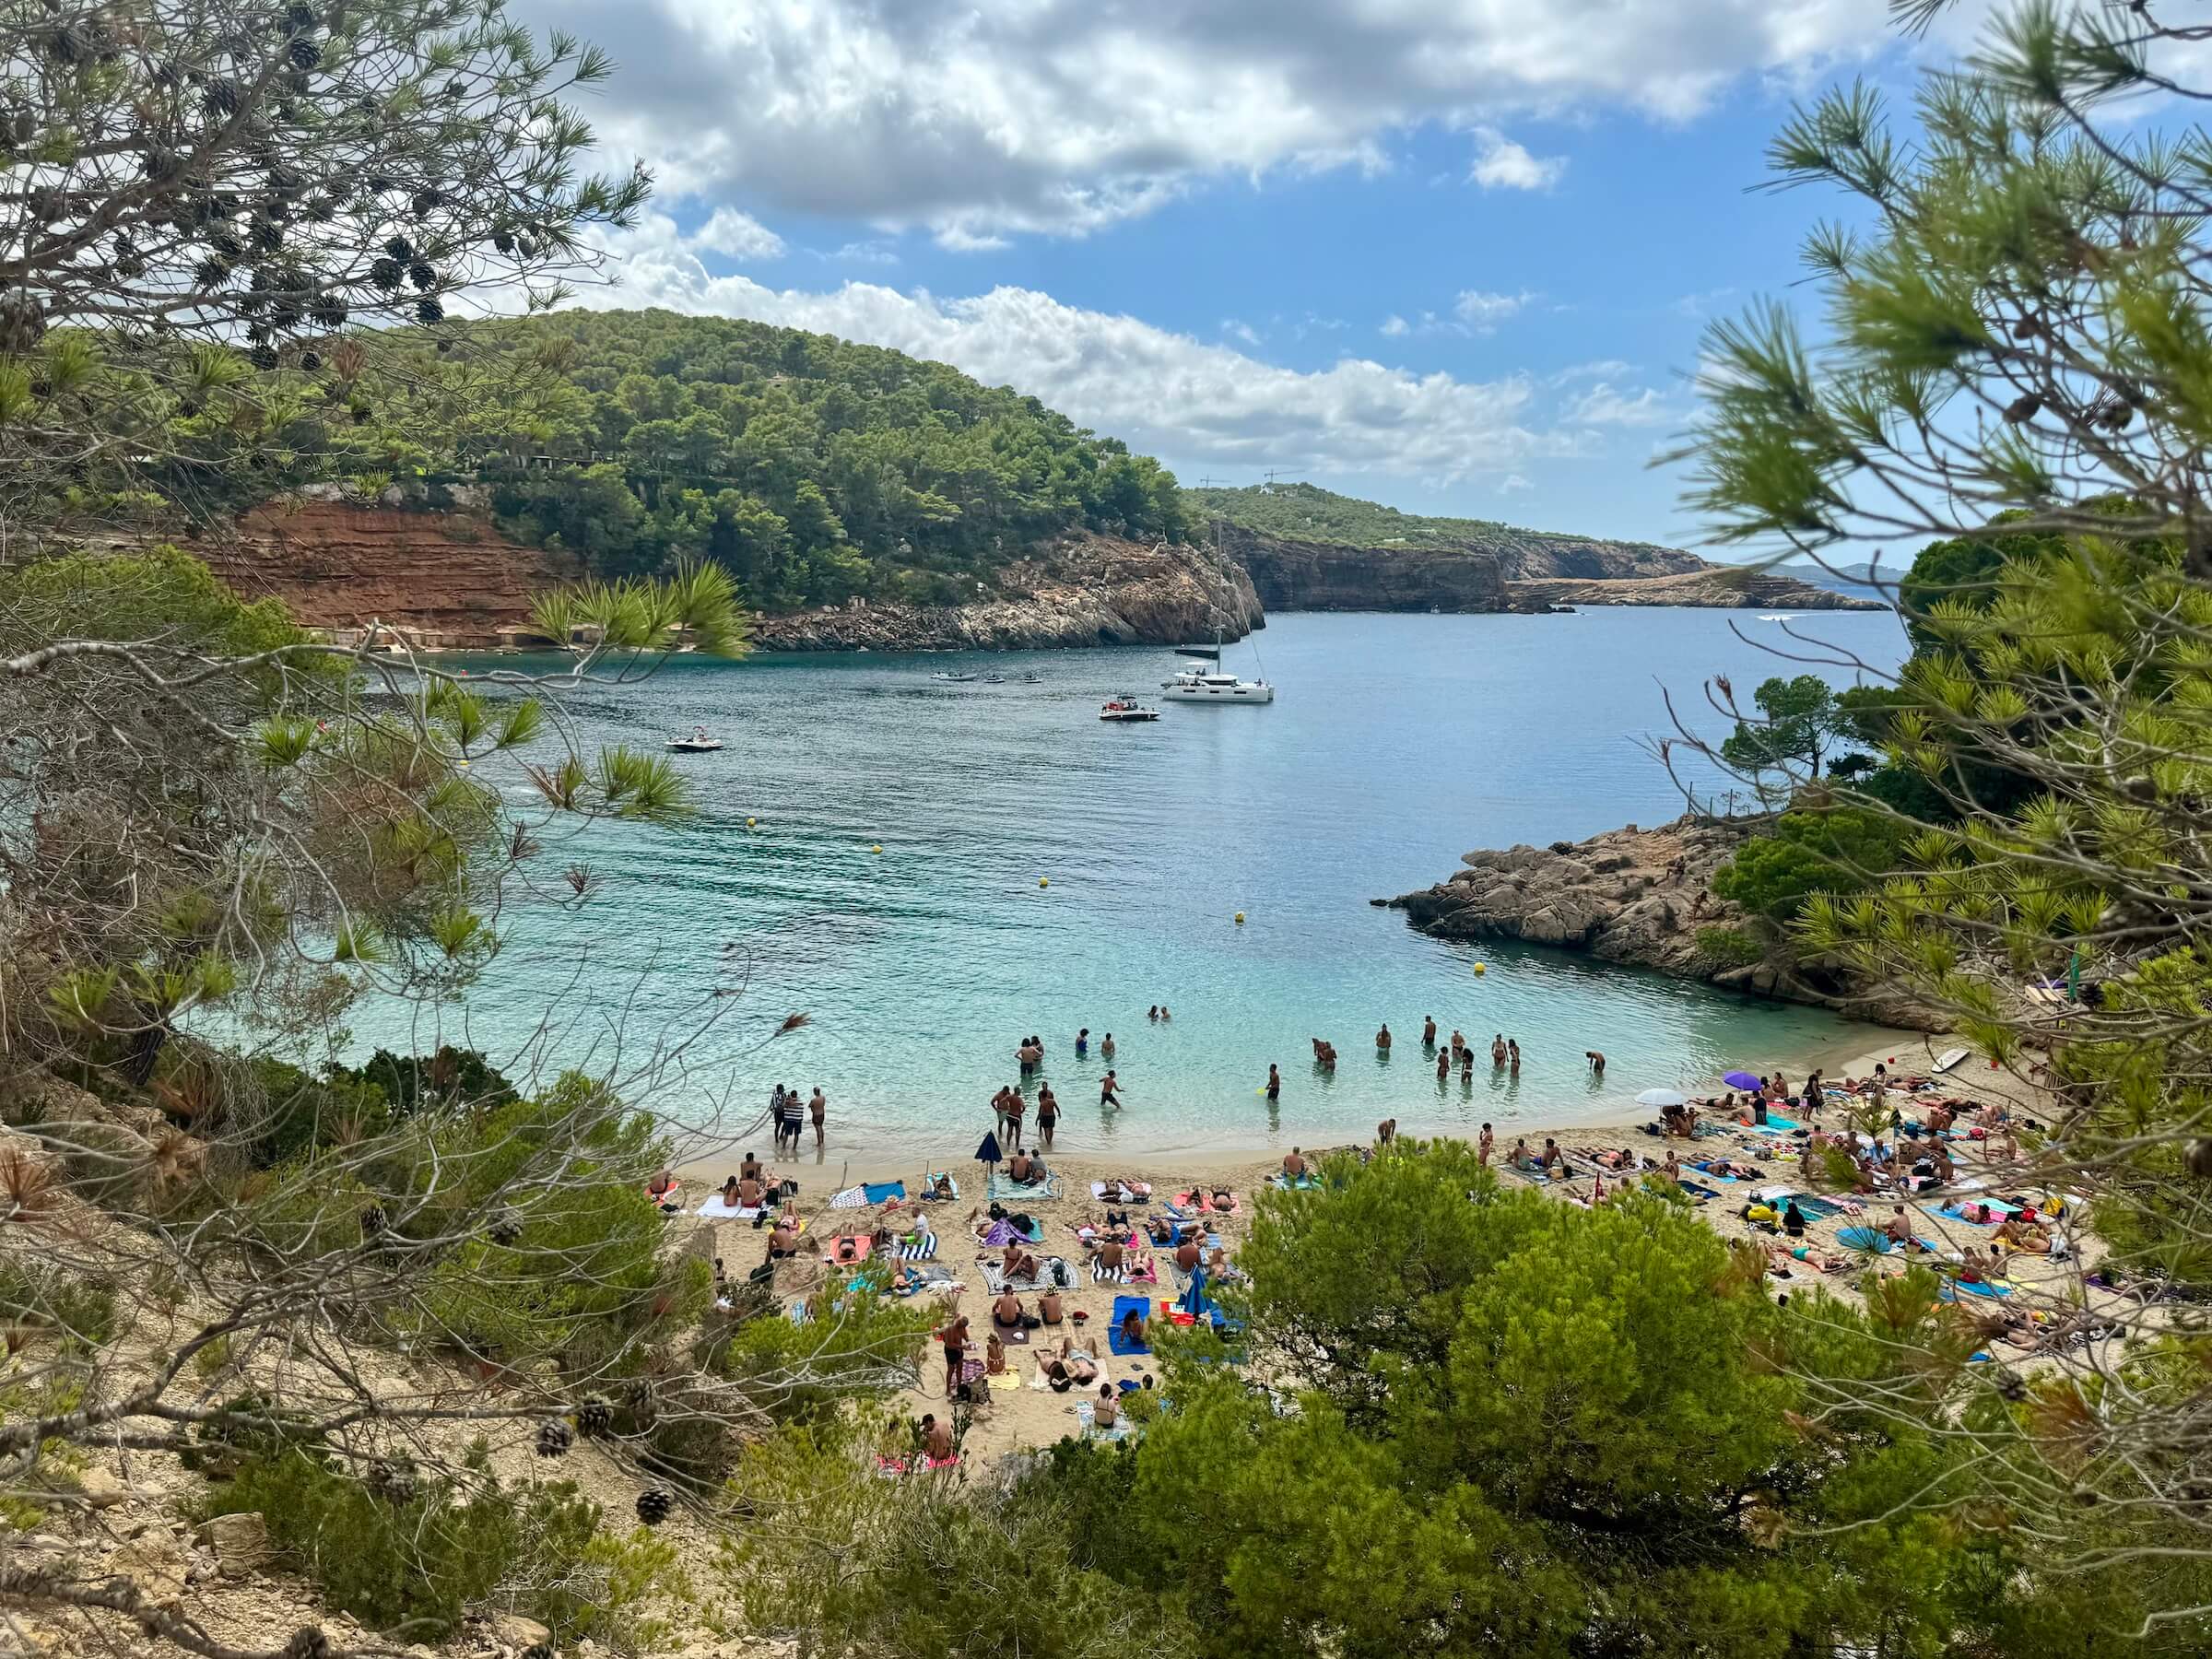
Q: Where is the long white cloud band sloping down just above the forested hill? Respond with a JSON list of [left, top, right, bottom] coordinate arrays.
[[586, 243, 1593, 485]]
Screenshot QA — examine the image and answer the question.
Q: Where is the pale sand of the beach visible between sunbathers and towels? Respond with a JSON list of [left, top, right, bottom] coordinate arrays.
[[664, 1033, 2081, 1455]]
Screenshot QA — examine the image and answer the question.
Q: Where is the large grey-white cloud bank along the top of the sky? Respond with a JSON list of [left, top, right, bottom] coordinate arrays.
[[513, 0, 1893, 245]]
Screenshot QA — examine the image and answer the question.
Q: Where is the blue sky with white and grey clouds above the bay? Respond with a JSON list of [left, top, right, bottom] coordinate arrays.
[[511, 0, 1978, 559]]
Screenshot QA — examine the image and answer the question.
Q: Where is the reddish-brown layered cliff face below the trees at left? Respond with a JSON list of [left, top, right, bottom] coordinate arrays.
[[193, 498, 582, 648]]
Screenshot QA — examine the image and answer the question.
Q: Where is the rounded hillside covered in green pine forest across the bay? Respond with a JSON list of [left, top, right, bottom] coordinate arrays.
[[343, 312, 1183, 608]]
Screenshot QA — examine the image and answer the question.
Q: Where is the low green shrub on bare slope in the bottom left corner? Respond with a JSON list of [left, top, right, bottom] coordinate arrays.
[[208, 1447, 599, 1641]]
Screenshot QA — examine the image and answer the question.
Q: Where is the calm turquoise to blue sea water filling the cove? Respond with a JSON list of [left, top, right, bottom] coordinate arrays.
[[371, 610, 1902, 1168]]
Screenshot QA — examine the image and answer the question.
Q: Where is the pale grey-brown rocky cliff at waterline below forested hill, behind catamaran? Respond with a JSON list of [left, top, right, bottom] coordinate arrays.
[[752, 533, 1265, 651]]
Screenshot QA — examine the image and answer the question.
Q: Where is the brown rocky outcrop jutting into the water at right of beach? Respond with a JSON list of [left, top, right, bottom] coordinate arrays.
[[1371, 814, 1948, 1030]]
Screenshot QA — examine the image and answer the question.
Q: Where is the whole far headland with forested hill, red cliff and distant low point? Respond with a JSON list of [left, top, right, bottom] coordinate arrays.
[[156, 312, 1865, 651]]
